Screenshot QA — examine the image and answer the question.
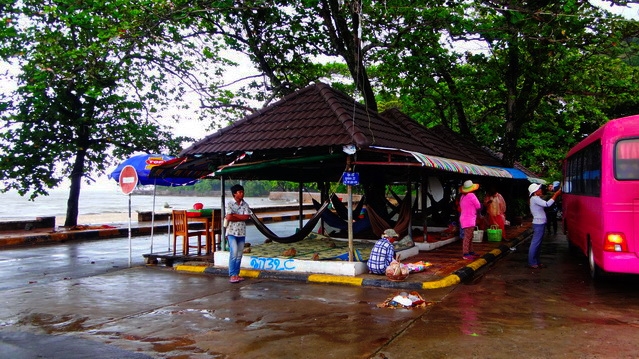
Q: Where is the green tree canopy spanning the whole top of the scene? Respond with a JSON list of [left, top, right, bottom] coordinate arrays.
[[0, 0, 639, 224]]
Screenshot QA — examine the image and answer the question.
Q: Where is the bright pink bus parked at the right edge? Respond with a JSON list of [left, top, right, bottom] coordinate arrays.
[[561, 115, 639, 279]]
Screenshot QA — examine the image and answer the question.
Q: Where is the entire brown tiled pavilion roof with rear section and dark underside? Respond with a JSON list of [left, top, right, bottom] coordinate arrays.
[[162, 83, 516, 182]]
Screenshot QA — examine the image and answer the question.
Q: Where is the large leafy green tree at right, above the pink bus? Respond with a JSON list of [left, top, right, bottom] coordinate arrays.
[[379, 0, 638, 176]]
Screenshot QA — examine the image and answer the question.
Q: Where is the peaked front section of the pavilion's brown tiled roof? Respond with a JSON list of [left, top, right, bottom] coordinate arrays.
[[180, 83, 424, 156]]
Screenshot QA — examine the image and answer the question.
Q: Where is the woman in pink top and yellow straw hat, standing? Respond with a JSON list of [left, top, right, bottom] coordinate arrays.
[[459, 180, 481, 260]]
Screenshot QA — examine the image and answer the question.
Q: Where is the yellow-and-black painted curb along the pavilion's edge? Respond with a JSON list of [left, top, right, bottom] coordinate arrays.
[[174, 230, 532, 290]]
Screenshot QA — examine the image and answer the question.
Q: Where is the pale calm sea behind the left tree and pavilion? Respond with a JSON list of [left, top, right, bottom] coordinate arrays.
[[0, 188, 289, 220]]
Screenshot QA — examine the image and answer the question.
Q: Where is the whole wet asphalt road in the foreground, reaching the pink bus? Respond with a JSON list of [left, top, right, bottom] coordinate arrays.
[[0, 226, 639, 359]]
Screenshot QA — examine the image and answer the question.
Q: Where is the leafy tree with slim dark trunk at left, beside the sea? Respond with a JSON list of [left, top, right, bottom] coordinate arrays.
[[0, 0, 220, 226]]
